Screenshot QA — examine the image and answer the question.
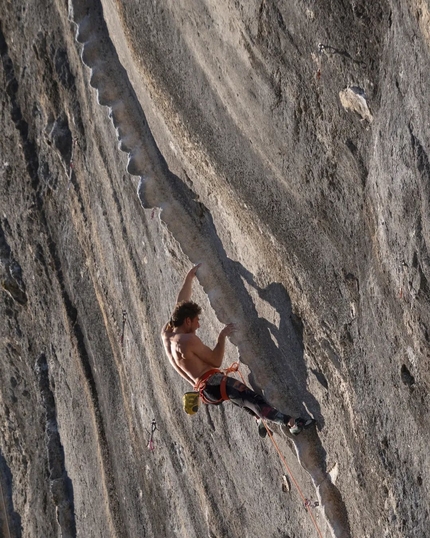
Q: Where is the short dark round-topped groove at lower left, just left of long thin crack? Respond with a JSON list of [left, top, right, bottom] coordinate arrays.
[[35, 353, 76, 538]]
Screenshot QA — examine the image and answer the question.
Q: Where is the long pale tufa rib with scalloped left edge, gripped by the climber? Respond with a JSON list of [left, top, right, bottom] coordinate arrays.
[[69, 0, 350, 538]]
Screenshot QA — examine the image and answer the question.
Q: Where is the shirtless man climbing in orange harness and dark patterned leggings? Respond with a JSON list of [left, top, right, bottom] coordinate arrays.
[[161, 263, 315, 437]]
